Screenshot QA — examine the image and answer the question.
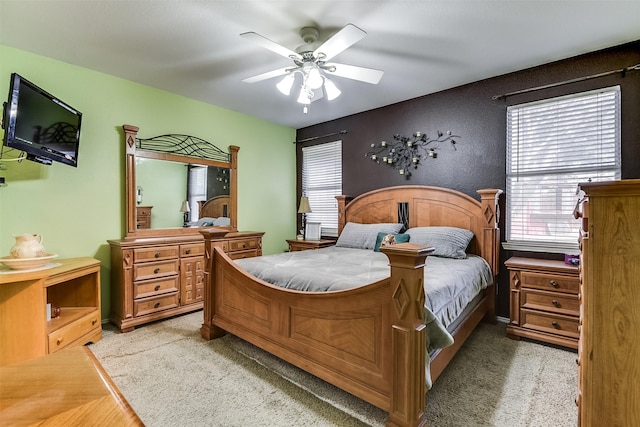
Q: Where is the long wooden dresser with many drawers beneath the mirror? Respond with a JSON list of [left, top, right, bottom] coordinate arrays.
[[108, 232, 264, 332]]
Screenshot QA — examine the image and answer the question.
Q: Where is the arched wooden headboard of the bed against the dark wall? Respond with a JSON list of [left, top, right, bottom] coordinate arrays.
[[338, 185, 502, 275]]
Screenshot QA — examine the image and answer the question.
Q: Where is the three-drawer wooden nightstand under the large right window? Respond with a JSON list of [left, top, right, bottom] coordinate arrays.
[[504, 257, 580, 349]]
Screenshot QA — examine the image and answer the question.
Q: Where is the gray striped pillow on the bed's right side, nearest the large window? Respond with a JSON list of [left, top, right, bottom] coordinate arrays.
[[405, 227, 473, 259]]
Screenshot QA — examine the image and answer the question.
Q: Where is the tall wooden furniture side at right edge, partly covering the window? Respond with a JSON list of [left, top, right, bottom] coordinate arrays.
[[577, 179, 640, 427]]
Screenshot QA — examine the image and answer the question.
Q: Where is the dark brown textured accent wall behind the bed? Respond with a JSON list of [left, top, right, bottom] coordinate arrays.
[[297, 40, 640, 317]]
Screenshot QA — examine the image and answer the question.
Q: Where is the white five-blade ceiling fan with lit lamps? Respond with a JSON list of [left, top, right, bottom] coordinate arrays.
[[240, 24, 384, 113]]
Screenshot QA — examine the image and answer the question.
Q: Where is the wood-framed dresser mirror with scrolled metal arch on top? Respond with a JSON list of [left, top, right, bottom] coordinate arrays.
[[123, 125, 239, 237]]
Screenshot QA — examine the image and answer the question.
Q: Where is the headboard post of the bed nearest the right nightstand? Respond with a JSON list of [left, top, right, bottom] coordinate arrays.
[[478, 189, 502, 323]]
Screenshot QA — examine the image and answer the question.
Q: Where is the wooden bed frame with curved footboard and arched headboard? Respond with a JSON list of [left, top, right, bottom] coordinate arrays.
[[200, 185, 502, 426]]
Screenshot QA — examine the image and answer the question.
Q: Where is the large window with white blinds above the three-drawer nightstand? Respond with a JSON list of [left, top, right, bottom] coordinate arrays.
[[504, 86, 621, 253]]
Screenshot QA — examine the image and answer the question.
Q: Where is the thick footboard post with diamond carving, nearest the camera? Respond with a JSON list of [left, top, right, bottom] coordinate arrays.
[[381, 243, 433, 427]]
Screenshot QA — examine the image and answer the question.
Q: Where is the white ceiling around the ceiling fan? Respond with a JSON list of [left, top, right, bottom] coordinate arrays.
[[0, 0, 640, 128]]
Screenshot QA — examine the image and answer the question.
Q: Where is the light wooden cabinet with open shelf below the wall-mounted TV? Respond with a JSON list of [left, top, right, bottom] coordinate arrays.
[[0, 258, 102, 366]]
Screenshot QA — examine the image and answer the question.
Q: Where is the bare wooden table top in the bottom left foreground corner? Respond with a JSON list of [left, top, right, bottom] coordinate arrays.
[[0, 346, 144, 426]]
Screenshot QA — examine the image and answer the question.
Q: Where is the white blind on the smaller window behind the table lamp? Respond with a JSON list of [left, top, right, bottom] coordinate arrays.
[[302, 141, 342, 237]]
